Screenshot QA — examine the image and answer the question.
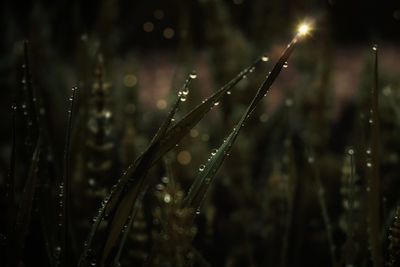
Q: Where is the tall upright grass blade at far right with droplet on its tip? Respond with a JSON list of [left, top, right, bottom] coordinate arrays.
[[367, 46, 383, 267]]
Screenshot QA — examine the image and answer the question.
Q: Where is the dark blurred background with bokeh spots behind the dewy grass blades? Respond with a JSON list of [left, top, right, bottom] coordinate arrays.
[[0, 0, 400, 266]]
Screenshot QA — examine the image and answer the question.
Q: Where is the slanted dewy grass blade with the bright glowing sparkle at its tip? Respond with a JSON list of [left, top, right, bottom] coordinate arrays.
[[185, 36, 298, 210]]
